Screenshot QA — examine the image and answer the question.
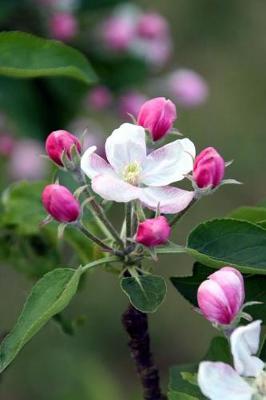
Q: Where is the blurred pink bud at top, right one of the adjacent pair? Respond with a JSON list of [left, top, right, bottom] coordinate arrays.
[[137, 13, 168, 39]]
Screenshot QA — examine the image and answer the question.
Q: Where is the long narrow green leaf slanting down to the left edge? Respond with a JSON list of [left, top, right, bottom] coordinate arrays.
[[0, 268, 82, 372]]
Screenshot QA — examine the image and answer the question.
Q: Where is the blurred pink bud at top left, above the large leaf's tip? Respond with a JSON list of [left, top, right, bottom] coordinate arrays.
[[50, 12, 78, 41]]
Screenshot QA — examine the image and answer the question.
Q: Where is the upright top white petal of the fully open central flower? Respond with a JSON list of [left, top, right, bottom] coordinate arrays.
[[105, 123, 146, 174]]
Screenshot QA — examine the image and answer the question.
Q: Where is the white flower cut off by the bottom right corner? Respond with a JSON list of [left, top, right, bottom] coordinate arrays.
[[198, 321, 266, 400]]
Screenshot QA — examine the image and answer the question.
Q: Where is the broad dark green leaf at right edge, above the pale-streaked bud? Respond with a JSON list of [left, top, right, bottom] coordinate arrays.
[[187, 219, 266, 274]]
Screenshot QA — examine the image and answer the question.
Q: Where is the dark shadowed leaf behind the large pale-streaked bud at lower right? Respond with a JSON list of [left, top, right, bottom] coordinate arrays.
[[170, 263, 266, 324]]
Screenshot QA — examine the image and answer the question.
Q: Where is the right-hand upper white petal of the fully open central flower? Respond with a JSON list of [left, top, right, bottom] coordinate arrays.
[[141, 139, 195, 186]]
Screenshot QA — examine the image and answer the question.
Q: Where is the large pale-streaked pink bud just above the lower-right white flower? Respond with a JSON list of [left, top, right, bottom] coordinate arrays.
[[198, 267, 245, 325]]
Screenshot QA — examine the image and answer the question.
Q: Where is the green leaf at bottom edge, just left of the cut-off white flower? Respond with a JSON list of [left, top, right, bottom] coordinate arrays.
[[168, 364, 205, 400]]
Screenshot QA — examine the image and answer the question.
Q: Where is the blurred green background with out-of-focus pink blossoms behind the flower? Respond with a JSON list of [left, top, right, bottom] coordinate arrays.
[[0, 0, 266, 400]]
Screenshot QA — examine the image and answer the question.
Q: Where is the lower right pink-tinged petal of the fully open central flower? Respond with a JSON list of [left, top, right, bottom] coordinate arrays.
[[139, 186, 194, 214]]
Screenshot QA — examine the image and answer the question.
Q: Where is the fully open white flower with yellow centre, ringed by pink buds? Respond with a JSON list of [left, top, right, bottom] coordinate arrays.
[[81, 123, 195, 214]]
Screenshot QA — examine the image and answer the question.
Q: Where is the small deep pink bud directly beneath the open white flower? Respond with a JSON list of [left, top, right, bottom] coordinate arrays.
[[136, 216, 171, 247]]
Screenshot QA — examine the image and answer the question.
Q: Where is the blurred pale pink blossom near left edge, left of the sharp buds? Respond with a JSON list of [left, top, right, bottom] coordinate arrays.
[[9, 139, 48, 180]]
